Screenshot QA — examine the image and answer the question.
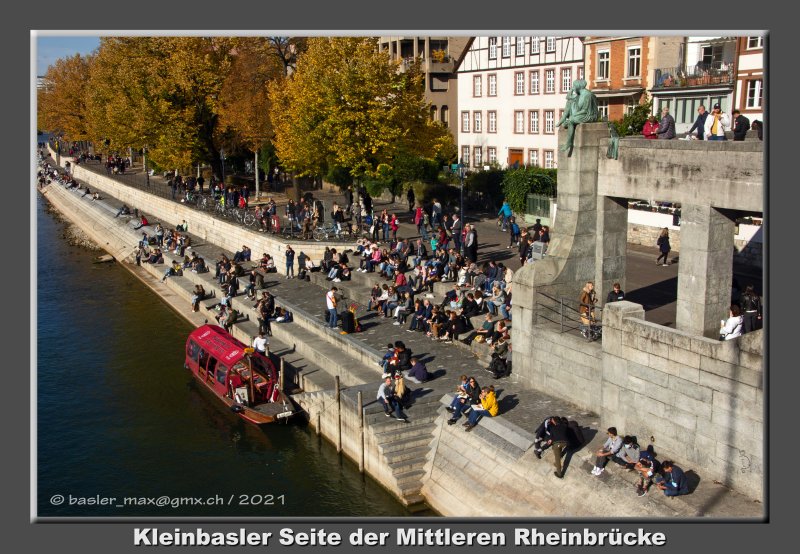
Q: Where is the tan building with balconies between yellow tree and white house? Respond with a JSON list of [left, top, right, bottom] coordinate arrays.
[[378, 37, 469, 138]]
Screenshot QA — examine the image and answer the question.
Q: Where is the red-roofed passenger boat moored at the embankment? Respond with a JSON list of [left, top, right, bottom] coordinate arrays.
[[184, 325, 295, 425]]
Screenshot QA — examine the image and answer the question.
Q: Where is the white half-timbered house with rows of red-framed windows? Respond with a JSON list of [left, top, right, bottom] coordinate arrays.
[[457, 36, 584, 170]]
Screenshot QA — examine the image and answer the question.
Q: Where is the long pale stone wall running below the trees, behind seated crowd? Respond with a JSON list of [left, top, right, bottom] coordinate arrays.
[[73, 165, 352, 273]]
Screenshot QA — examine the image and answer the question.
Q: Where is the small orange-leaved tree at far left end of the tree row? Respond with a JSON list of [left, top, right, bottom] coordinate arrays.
[[36, 54, 92, 141]]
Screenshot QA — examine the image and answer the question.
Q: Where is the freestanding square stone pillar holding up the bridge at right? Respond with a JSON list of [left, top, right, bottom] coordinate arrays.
[[675, 204, 734, 338]]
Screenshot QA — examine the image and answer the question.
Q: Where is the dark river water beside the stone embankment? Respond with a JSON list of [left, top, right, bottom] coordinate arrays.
[[36, 197, 416, 517]]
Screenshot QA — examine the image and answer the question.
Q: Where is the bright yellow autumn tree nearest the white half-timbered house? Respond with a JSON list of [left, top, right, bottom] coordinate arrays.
[[269, 37, 448, 183]]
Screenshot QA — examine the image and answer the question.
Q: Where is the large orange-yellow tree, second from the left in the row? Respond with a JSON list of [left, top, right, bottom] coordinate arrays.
[[87, 37, 232, 174]]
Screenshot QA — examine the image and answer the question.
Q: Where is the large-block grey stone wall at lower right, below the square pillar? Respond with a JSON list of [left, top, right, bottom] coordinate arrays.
[[514, 302, 765, 498]]
